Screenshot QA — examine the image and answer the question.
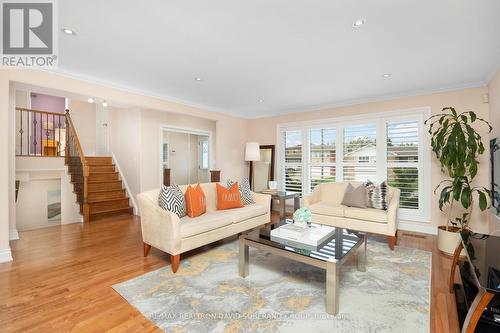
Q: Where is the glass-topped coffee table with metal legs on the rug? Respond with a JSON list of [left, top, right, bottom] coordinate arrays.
[[239, 221, 366, 314]]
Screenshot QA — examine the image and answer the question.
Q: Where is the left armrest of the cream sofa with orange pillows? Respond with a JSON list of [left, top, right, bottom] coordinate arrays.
[[137, 193, 181, 255]]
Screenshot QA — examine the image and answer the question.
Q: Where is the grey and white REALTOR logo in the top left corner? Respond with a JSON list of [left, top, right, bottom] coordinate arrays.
[[1, 0, 57, 67]]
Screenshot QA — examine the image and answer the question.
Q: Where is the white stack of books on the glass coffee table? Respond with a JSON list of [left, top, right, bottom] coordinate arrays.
[[271, 224, 335, 251]]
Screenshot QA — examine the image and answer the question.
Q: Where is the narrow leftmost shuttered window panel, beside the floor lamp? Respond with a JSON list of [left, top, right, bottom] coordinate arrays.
[[283, 130, 302, 193]]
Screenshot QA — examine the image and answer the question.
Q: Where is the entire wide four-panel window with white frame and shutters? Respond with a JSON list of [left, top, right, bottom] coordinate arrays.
[[278, 109, 431, 222]]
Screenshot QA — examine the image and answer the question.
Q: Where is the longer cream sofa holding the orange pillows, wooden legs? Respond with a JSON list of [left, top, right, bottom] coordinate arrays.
[[137, 183, 271, 273]]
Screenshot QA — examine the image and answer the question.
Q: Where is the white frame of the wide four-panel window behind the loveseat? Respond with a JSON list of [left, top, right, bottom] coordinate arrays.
[[276, 107, 431, 223]]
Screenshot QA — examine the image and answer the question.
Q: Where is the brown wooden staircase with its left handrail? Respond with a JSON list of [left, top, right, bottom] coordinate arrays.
[[65, 111, 133, 222]]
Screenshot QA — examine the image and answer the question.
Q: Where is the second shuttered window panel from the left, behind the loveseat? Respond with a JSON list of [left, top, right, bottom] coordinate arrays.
[[309, 128, 337, 190]]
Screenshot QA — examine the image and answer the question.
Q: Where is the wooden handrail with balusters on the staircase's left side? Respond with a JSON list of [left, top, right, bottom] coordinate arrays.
[[65, 110, 90, 222]]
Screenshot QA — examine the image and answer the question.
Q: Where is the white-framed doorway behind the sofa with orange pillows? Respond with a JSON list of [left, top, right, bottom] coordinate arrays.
[[160, 127, 211, 185]]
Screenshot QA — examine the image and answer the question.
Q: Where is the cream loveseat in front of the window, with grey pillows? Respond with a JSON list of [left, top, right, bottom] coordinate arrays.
[[304, 182, 400, 249]]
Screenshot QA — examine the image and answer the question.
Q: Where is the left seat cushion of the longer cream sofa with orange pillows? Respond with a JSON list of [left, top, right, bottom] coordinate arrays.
[[181, 212, 233, 238]]
